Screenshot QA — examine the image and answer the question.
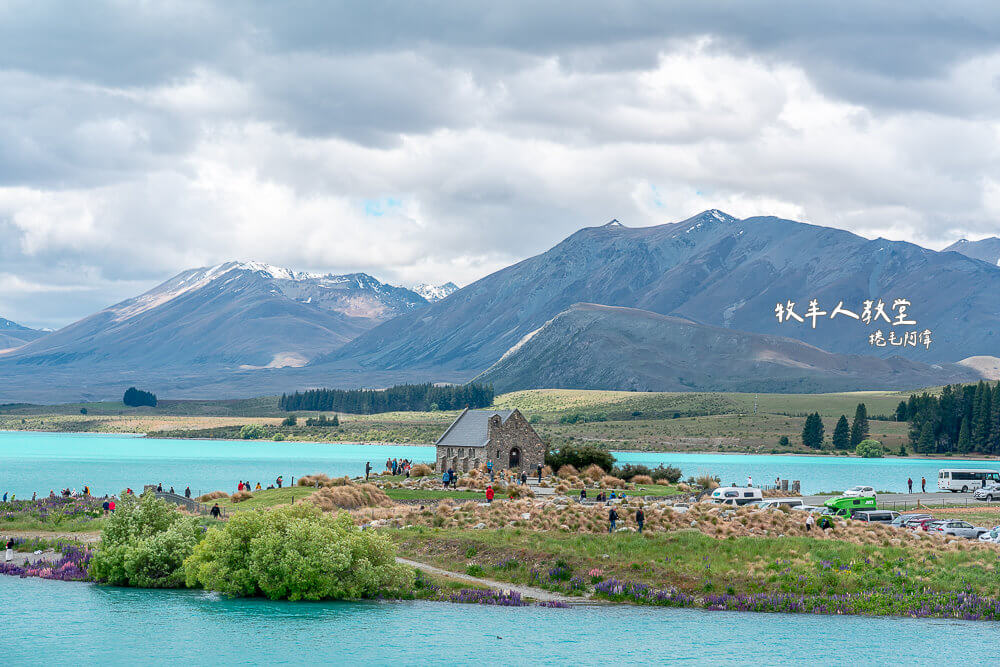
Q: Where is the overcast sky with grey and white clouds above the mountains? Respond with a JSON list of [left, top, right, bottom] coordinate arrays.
[[0, 0, 1000, 327]]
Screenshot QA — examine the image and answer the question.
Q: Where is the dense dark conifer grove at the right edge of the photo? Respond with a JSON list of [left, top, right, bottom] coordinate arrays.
[[908, 381, 1000, 454]]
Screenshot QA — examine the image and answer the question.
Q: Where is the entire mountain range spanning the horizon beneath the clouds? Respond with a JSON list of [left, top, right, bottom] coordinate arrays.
[[0, 210, 1000, 402]]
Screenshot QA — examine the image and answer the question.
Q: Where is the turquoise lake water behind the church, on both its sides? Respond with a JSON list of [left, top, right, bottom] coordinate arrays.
[[0, 431, 1000, 498]]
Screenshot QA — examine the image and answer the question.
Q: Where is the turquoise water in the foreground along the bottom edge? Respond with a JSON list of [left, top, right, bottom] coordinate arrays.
[[0, 576, 1000, 665]]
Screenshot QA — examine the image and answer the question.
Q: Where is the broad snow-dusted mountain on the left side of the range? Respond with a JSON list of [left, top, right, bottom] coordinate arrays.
[[0, 262, 427, 371]]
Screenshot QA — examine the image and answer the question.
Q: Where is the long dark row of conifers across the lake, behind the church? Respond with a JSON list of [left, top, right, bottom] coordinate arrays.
[[278, 382, 494, 415]]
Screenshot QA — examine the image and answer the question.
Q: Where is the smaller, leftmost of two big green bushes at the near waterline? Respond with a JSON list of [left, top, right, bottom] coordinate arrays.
[[89, 491, 203, 588]]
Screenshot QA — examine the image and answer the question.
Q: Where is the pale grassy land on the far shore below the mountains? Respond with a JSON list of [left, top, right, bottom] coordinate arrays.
[[0, 389, 928, 453]]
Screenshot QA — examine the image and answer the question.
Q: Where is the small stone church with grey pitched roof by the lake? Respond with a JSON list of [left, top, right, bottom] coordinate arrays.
[[435, 408, 545, 474]]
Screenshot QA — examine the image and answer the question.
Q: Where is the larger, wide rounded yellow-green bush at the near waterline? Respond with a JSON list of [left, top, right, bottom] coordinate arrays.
[[184, 503, 414, 600]]
